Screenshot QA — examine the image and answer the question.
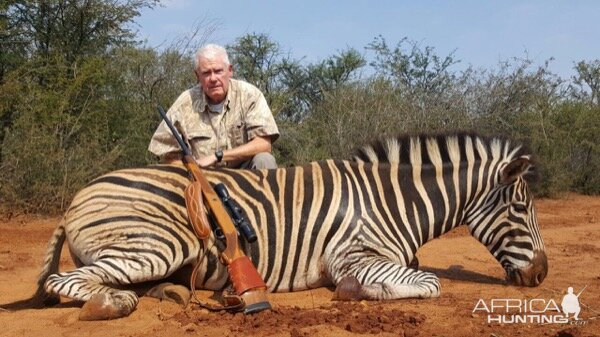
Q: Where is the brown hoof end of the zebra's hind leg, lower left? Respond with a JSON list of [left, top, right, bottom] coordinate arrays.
[[79, 293, 133, 321]]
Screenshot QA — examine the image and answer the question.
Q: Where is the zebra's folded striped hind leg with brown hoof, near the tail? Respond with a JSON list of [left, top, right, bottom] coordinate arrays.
[[44, 258, 150, 320]]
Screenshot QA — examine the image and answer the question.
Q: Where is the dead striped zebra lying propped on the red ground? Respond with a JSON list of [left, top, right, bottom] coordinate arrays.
[[2, 134, 548, 319]]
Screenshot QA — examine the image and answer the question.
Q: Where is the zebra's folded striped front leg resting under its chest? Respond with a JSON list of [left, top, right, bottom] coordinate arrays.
[[328, 256, 440, 300]]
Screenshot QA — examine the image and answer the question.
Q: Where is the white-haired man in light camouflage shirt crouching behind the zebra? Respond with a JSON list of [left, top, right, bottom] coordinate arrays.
[[148, 44, 279, 169]]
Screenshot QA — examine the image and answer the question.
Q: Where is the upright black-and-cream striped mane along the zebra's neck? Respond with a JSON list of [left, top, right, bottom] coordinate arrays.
[[352, 132, 533, 173]]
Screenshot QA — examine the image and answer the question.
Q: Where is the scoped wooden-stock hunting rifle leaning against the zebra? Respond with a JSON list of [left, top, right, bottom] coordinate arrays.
[[157, 105, 271, 314]]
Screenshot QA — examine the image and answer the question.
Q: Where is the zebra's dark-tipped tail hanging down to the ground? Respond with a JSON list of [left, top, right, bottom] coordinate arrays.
[[0, 218, 66, 310]]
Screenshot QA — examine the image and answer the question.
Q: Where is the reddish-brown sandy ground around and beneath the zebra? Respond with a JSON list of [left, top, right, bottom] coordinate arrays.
[[0, 195, 600, 337]]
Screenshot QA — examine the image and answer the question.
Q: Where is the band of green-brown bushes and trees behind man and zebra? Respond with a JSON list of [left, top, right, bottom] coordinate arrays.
[[0, 0, 600, 213]]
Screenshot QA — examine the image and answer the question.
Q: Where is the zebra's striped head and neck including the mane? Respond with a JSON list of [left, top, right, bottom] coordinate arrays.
[[354, 134, 547, 285]]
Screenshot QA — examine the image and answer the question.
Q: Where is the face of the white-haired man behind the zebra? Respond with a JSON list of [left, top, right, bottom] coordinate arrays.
[[194, 58, 233, 104]]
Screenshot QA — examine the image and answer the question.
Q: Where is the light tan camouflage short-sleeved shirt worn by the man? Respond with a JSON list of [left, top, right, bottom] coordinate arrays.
[[148, 79, 279, 159]]
